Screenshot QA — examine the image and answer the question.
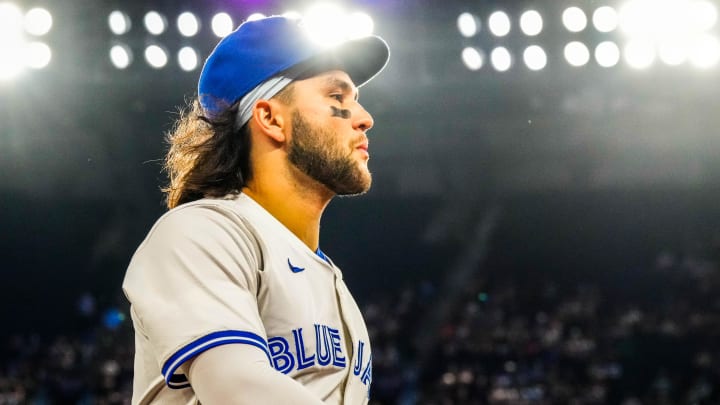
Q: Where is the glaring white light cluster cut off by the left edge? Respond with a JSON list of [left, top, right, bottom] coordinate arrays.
[[0, 3, 53, 80]]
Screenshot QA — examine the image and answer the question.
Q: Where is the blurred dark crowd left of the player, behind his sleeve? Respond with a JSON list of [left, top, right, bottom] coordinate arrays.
[[0, 324, 133, 405]]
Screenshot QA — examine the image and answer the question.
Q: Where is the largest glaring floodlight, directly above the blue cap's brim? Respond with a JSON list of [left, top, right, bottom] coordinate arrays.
[[304, 3, 347, 46]]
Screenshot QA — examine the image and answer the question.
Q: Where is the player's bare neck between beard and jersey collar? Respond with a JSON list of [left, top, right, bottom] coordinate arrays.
[[242, 176, 332, 251]]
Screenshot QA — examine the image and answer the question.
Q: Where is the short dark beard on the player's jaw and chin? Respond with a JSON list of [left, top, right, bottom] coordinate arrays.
[[288, 111, 372, 195]]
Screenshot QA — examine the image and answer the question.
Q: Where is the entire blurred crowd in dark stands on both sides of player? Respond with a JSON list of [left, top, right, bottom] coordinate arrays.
[[0, 235, 720, 405]]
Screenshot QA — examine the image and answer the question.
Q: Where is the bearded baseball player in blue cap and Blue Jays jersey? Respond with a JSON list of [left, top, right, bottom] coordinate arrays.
[[123, 17, 389, 405]]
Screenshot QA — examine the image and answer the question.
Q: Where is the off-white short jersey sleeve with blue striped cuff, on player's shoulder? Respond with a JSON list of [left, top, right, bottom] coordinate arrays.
[[123, 205, 270, 388]]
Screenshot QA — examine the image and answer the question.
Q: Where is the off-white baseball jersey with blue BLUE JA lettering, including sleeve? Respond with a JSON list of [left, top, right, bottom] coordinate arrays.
[[123, 194, 372, 404]]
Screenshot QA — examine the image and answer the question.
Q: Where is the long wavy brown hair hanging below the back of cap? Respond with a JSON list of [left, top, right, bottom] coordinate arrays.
[[162, 99, 252, 209]]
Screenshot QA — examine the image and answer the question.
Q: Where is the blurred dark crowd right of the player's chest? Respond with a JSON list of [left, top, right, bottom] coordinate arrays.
[[365, 241, 720, 405]]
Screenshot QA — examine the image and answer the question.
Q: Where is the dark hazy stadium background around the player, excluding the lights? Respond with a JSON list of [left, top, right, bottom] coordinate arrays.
[[0, 0, 720, 405]]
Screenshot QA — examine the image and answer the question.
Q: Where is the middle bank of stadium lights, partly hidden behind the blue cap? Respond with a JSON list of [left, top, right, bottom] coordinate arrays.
[[108, 3, 374, 72]]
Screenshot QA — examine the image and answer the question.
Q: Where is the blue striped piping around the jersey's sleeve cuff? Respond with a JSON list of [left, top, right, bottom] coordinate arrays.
[[162, 330, 272, 389]]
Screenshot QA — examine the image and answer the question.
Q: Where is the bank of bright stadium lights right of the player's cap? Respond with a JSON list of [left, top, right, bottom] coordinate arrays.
[[457, 0, 720, 72]]
